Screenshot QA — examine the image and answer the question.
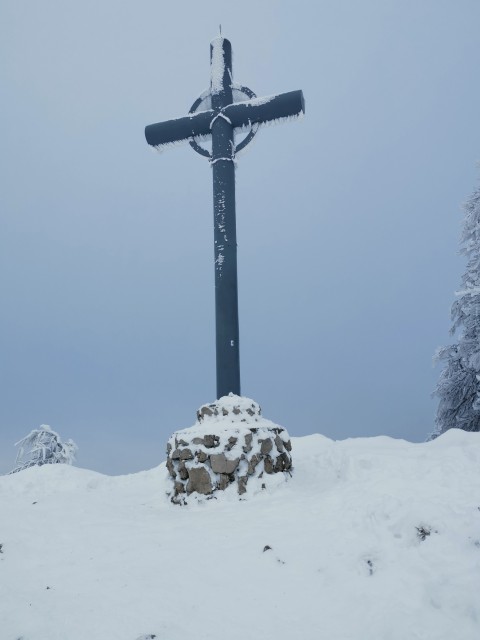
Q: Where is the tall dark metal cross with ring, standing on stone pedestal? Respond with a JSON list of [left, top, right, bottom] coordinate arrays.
[[145, 37, 305, 398]]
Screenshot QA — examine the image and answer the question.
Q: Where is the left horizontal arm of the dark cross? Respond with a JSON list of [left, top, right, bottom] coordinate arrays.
[[145, 109, 215, 147]]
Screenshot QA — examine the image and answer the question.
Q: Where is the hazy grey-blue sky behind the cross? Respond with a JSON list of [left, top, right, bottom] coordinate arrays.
[[0, 0, 480, 473]]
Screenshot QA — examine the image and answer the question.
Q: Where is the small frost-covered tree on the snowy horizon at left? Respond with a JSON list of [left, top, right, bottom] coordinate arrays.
[[11, 424, 78, 473]]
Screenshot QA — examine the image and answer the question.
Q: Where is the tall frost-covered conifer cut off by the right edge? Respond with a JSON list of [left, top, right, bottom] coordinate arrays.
[[430, 181, 480, 439]]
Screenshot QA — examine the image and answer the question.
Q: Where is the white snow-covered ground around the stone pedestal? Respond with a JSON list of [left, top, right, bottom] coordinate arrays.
[[0, 430, 480, 640]]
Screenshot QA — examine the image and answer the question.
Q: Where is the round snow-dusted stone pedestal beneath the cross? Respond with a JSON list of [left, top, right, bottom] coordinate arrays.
[[167, 394, 292, 504]]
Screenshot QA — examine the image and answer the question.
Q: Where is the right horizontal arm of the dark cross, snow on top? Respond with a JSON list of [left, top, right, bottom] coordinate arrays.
[[222, 91, 305, 129]]
